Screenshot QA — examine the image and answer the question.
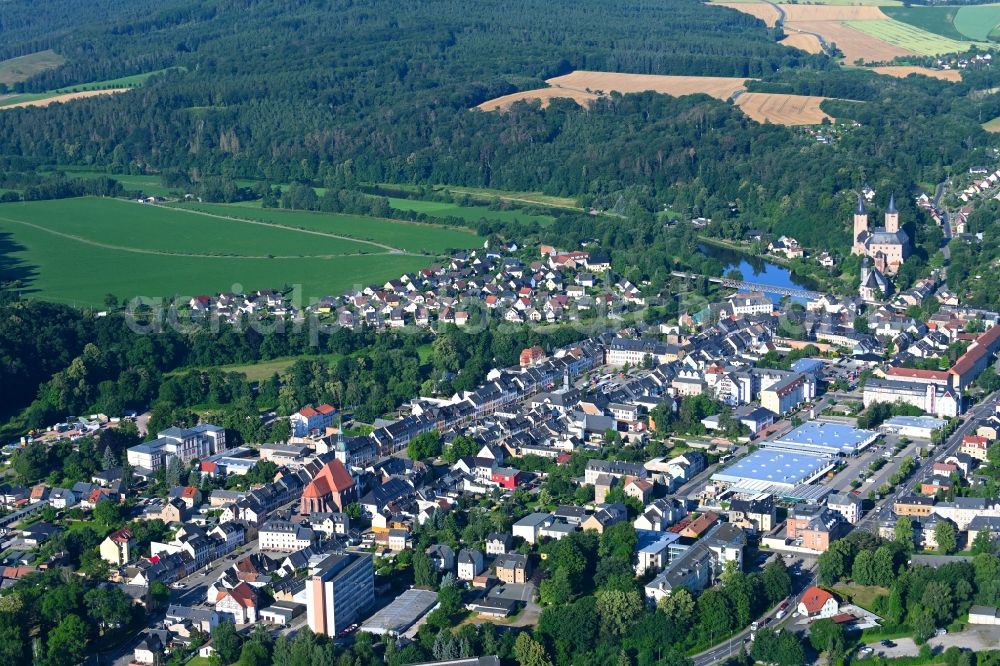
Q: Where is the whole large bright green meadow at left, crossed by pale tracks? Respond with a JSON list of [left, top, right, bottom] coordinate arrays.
[[0, 197, 480, 306]]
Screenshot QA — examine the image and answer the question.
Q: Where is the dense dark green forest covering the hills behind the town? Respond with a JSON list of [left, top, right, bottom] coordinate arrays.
[[0, 0, 1000, 260]]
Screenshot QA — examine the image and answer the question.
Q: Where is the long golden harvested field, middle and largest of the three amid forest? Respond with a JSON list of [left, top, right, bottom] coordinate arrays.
[[546, 69, 747, 99]]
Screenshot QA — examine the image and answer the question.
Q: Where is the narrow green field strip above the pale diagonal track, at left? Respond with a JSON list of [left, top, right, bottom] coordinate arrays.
[[172, 198, 482, 254]]
